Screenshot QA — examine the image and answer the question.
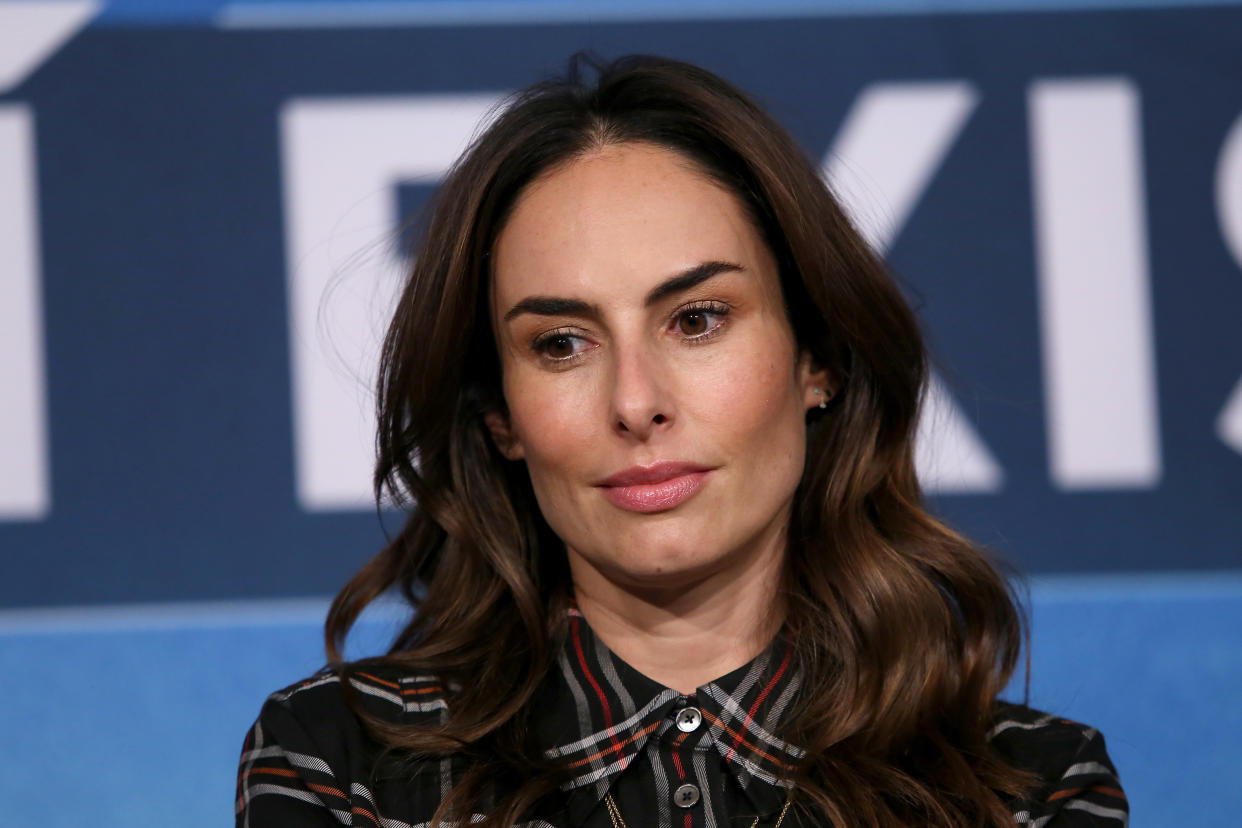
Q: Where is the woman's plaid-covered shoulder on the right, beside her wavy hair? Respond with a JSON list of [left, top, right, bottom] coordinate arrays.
[[989, 703, 1129, 828]]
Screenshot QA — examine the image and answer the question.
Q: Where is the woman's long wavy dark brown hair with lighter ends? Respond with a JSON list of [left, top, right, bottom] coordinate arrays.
[[325, 57, 1030, 828]]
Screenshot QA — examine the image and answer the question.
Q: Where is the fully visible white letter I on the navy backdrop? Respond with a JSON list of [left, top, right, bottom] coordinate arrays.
[[1027, 78, 1160, 489]]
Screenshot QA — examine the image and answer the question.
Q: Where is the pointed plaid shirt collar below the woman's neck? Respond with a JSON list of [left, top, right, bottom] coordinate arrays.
[[535, 607, 804, 824]]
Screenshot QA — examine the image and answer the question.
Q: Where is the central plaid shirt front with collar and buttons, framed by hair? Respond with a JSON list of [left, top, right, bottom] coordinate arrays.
[[540, 611, 797, 828]]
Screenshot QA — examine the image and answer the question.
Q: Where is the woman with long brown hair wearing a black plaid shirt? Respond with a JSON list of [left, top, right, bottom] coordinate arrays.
[[237, 58, 1126, 828]]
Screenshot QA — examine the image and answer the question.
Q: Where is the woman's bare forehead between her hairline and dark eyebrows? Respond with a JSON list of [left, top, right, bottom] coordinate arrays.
[[493, 144, 769, 304]]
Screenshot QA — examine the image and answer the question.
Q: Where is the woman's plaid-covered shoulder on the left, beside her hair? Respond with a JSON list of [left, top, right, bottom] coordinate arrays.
[[235, 665, 446, 826]]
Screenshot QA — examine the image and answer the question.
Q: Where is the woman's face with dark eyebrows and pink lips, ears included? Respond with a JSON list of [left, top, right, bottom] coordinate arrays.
[[488, 144, 825, 587]]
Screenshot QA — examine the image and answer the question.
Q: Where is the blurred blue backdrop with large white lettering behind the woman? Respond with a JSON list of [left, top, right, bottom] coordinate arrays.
[[0, 0, 1242, 828]]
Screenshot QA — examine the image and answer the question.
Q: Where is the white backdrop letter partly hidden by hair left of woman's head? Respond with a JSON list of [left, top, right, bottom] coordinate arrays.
[[281, 94, 498, 511]]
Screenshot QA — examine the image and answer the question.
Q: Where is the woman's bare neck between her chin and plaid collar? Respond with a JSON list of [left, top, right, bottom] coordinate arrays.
[[570, 531, 785, 694]]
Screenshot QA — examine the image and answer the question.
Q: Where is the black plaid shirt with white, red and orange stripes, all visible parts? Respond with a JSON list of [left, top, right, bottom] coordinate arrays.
[[236, 611, 1126, 828]]
